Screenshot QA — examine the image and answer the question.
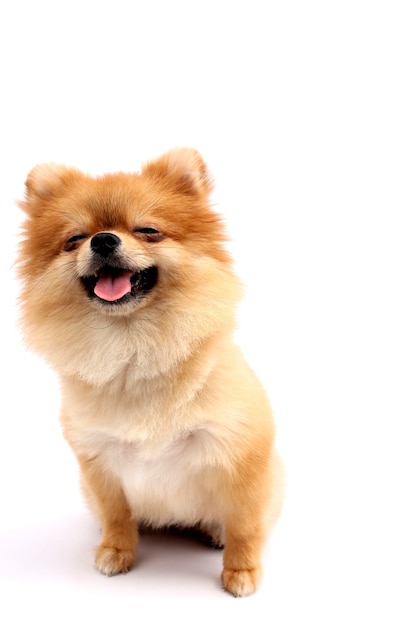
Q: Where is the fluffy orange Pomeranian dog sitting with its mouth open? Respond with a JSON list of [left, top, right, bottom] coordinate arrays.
[[18, 148, 283, 596]]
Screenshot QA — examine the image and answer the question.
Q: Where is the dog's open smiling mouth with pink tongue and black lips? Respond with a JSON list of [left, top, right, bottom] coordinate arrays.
[[81, 265, 158, 304]]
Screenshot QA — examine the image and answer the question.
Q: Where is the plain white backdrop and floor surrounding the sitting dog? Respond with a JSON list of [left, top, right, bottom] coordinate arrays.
[[0, 0, 417, 626]]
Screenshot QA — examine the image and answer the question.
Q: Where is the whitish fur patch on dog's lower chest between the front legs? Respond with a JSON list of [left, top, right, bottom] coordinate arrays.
[[82, 420, 228, 527]]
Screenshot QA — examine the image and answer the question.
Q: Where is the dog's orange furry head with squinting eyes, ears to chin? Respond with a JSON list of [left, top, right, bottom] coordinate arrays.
[[20, 148, 234, 315]]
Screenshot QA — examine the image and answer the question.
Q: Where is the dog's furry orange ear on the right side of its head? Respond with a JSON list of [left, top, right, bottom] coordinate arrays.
[[142, 148, 213, 196]]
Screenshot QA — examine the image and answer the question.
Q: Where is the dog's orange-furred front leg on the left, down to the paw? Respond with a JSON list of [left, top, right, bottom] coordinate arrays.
[[78, 450, 139, 576]]
